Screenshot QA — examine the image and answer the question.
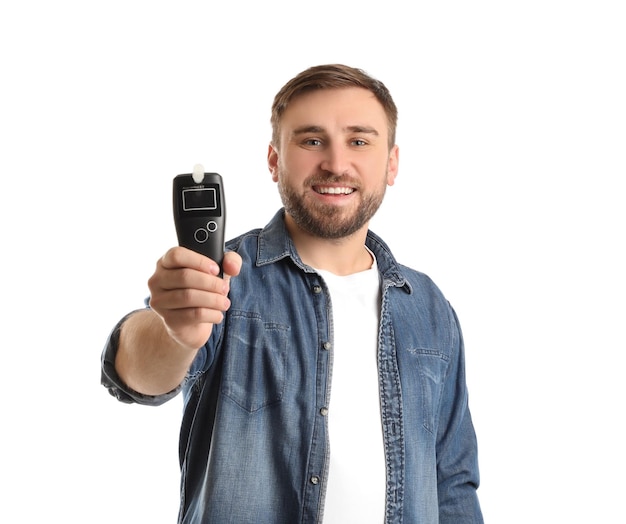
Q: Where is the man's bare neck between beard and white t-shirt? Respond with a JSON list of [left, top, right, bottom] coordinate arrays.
[[285, 215, 373, 276]]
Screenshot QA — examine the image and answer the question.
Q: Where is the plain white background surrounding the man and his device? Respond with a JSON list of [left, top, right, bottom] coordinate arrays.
[[0, 0, 626, 524]]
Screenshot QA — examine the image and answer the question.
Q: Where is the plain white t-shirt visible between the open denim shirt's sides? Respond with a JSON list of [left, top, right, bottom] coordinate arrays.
[[318, 255, 385, 524]]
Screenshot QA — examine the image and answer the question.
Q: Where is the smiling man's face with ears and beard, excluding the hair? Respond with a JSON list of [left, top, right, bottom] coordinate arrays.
[[268, 87, 398, 239]]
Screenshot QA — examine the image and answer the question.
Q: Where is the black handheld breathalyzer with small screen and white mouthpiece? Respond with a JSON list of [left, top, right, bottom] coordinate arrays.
[[173, 164, 226, 275]]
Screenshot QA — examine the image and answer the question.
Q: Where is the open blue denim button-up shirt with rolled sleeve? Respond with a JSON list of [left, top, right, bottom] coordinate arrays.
[[102, 210, 483, 524]]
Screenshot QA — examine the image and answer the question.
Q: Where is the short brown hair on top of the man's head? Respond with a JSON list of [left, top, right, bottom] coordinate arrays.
[[270, 64, 398, 149]]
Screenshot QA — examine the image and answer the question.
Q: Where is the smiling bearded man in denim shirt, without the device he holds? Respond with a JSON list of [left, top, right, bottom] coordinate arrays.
[[102, 65, 482, 524]]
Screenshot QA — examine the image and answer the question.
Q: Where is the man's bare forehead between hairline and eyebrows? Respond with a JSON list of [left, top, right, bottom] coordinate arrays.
[[281, 87, 387, 137]]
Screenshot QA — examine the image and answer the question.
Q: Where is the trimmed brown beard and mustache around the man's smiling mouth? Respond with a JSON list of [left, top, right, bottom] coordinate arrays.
[[278, 170, 387, 239]]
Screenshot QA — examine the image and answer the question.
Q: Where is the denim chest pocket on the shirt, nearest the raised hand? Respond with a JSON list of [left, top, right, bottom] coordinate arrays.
[[222, 311, 289, 413]]
